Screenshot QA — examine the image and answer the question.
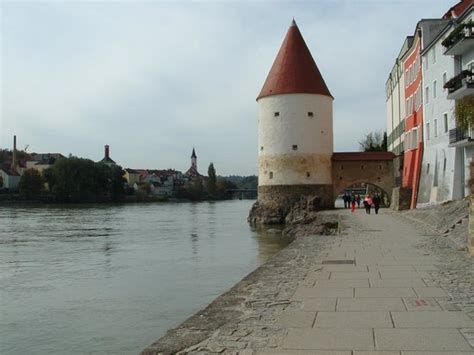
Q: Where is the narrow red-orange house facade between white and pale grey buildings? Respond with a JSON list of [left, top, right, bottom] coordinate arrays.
[[402, 31, 423, 208]]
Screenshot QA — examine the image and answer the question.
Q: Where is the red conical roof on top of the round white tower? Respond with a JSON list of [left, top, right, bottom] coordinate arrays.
[[257, 20, 332, 100]]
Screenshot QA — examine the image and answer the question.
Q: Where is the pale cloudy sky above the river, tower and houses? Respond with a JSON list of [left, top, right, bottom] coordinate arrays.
[[0, 0, 456, 175]]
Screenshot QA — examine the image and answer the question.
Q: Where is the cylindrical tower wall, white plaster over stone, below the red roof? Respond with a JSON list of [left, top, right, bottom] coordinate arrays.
[[258, 94, 333, 208]]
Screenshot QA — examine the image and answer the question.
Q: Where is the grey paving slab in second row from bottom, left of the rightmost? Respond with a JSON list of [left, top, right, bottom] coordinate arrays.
[[314, 312, 393, 328]]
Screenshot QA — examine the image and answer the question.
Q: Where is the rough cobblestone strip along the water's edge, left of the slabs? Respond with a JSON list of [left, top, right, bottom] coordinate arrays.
[[140, 210, 340, 355]]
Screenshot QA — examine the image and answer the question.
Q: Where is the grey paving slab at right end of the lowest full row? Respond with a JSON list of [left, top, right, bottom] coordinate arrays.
[[374, 328, 473, 351]]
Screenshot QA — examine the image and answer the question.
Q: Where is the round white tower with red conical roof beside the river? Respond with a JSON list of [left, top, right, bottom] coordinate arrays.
[[257, 20, 334, 208]]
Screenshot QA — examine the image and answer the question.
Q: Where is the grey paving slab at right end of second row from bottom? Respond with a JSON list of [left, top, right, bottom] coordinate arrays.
[[392, 311, 474, 328]]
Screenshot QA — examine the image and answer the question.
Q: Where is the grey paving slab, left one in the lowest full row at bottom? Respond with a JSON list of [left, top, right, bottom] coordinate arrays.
[[283, 328, 374, 350]]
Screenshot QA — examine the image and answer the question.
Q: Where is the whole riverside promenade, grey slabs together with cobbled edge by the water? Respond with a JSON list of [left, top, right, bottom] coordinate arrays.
[[143, 209, 474, 355]]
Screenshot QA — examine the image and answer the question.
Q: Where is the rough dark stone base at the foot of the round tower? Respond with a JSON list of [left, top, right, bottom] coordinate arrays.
[[248, 185, 334, 224]]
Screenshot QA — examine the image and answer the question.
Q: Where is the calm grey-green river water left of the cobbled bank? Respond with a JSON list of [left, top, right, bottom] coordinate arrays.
[[0, 200, 290, 354]]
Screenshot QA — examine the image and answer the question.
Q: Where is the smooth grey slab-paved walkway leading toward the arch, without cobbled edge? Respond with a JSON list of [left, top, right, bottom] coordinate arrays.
[[257, 210, 474, 355]]
